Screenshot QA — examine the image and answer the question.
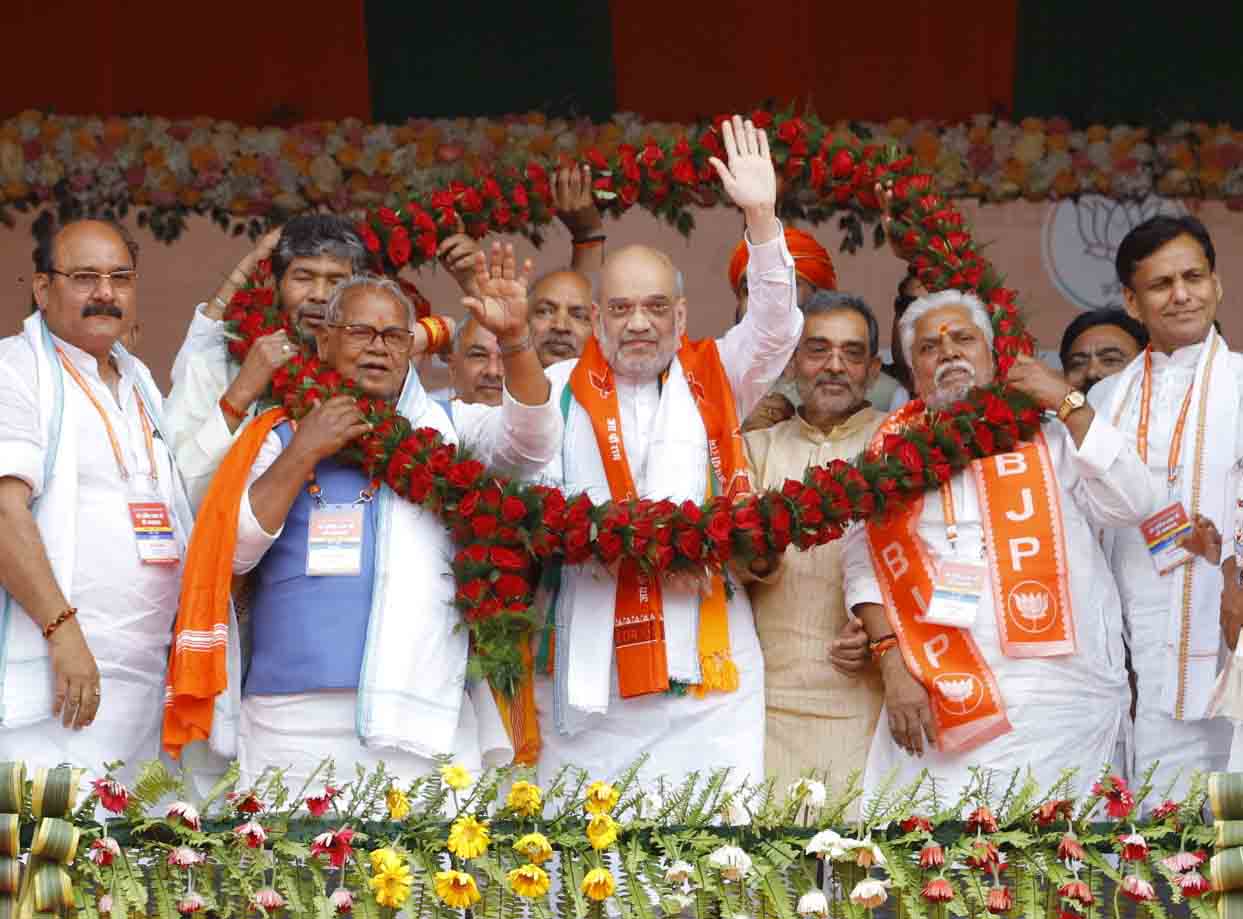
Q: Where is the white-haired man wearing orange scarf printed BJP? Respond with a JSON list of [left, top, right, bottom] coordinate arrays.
[[843, 290, 1155, 800]]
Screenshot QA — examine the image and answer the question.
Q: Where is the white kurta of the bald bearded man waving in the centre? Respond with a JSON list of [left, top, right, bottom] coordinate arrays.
[[536, 228, 802, 783]]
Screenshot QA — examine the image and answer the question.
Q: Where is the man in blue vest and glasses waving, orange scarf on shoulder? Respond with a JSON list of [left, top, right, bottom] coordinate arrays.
[[164, 254, 561, 787]]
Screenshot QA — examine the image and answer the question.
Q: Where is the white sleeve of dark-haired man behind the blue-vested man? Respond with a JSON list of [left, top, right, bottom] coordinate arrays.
[[165, 352, 246, 509]]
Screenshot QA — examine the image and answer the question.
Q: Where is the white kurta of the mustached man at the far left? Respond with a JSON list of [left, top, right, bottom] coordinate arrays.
[[0, 336, 188, 781]]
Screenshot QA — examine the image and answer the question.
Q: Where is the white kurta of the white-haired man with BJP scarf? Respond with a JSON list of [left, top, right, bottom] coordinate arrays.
[[843, 415, 1155, 801]]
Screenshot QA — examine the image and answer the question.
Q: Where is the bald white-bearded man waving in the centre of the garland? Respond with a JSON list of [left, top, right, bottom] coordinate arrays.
[[534, 117, 802, 787]]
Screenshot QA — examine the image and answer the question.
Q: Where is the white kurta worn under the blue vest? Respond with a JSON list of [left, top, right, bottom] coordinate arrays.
[[234, 371, 561, 787]]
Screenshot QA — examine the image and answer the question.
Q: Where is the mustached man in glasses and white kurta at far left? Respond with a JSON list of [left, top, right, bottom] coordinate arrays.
[[0, 220, 191, 781]]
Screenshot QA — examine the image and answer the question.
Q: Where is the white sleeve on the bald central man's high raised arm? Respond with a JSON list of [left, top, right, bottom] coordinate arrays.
[[716, 229, 803, 419]]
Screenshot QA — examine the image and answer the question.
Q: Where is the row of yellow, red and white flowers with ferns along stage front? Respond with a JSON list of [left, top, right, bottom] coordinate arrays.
[[0, 762, 1223, 919]]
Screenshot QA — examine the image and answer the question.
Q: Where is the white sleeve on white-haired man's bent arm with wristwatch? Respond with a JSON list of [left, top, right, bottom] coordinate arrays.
[[1045, 412, 1160, 527]]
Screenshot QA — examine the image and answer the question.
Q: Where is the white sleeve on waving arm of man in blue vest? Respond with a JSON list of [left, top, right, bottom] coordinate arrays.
[[452, 387, 562, 479]]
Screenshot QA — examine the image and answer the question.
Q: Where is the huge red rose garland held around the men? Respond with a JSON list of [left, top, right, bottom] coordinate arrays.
[[226, 112, 1040, 695]]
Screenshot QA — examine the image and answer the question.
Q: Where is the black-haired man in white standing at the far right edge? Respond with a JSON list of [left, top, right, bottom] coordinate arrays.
[[1090, 215, 1243, 798]]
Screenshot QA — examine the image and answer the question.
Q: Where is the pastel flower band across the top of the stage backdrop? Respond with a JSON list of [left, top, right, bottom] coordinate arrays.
[[7, 111, 1243, 240]]
